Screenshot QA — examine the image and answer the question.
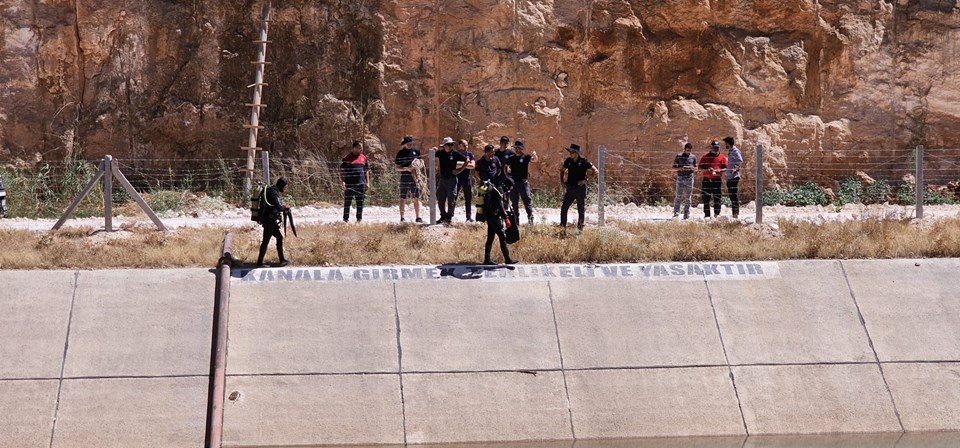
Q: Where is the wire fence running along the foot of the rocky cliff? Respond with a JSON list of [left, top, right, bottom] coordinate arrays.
[[0, 144, 960, 218]]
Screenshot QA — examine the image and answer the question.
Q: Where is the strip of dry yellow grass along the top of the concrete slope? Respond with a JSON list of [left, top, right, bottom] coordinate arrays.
[[0, 218, 960, 269]]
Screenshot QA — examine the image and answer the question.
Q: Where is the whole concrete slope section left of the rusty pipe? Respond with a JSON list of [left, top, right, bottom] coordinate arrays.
[[0, 269, 214, 448]]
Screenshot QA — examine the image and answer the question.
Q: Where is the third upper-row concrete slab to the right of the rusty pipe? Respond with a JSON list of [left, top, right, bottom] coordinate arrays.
[[551, 280, 725, 369]]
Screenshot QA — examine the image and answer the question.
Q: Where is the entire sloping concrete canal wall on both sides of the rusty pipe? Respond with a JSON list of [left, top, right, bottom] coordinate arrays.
[[0, 259, 960, 447]]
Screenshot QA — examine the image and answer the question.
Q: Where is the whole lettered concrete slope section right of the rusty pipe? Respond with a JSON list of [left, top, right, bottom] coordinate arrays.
[[224, 260, 960, 446]]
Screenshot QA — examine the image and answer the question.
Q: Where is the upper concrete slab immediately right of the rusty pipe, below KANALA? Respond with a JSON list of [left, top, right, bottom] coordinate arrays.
[[228, 283, 399, 375]]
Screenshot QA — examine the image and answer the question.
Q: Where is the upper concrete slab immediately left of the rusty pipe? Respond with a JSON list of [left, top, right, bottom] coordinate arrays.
[[64, 269, 214, 378]]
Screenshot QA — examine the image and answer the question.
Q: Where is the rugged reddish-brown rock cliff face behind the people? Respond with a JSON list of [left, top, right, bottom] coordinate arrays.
[[0, 0, 960, 193]]
